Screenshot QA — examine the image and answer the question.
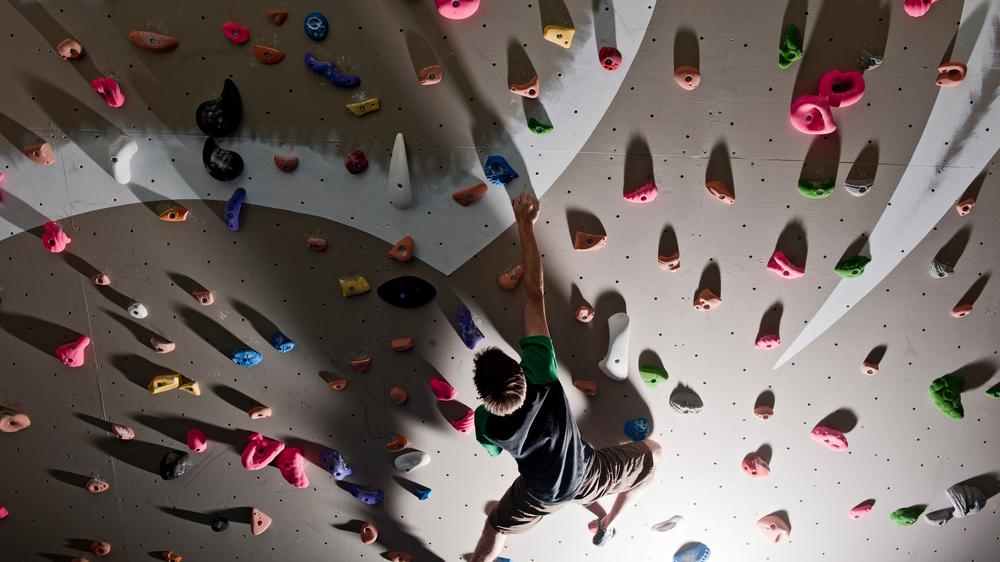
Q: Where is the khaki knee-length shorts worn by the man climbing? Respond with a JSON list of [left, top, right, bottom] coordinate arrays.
[[489, 441, 654, 535]]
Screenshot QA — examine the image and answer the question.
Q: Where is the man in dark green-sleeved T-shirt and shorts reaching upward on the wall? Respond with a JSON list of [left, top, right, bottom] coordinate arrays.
[[471, 194, 660, 562]]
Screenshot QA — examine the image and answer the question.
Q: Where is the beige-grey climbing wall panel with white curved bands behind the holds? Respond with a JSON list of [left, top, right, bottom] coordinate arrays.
[[0, 0, 1000, 562]]
